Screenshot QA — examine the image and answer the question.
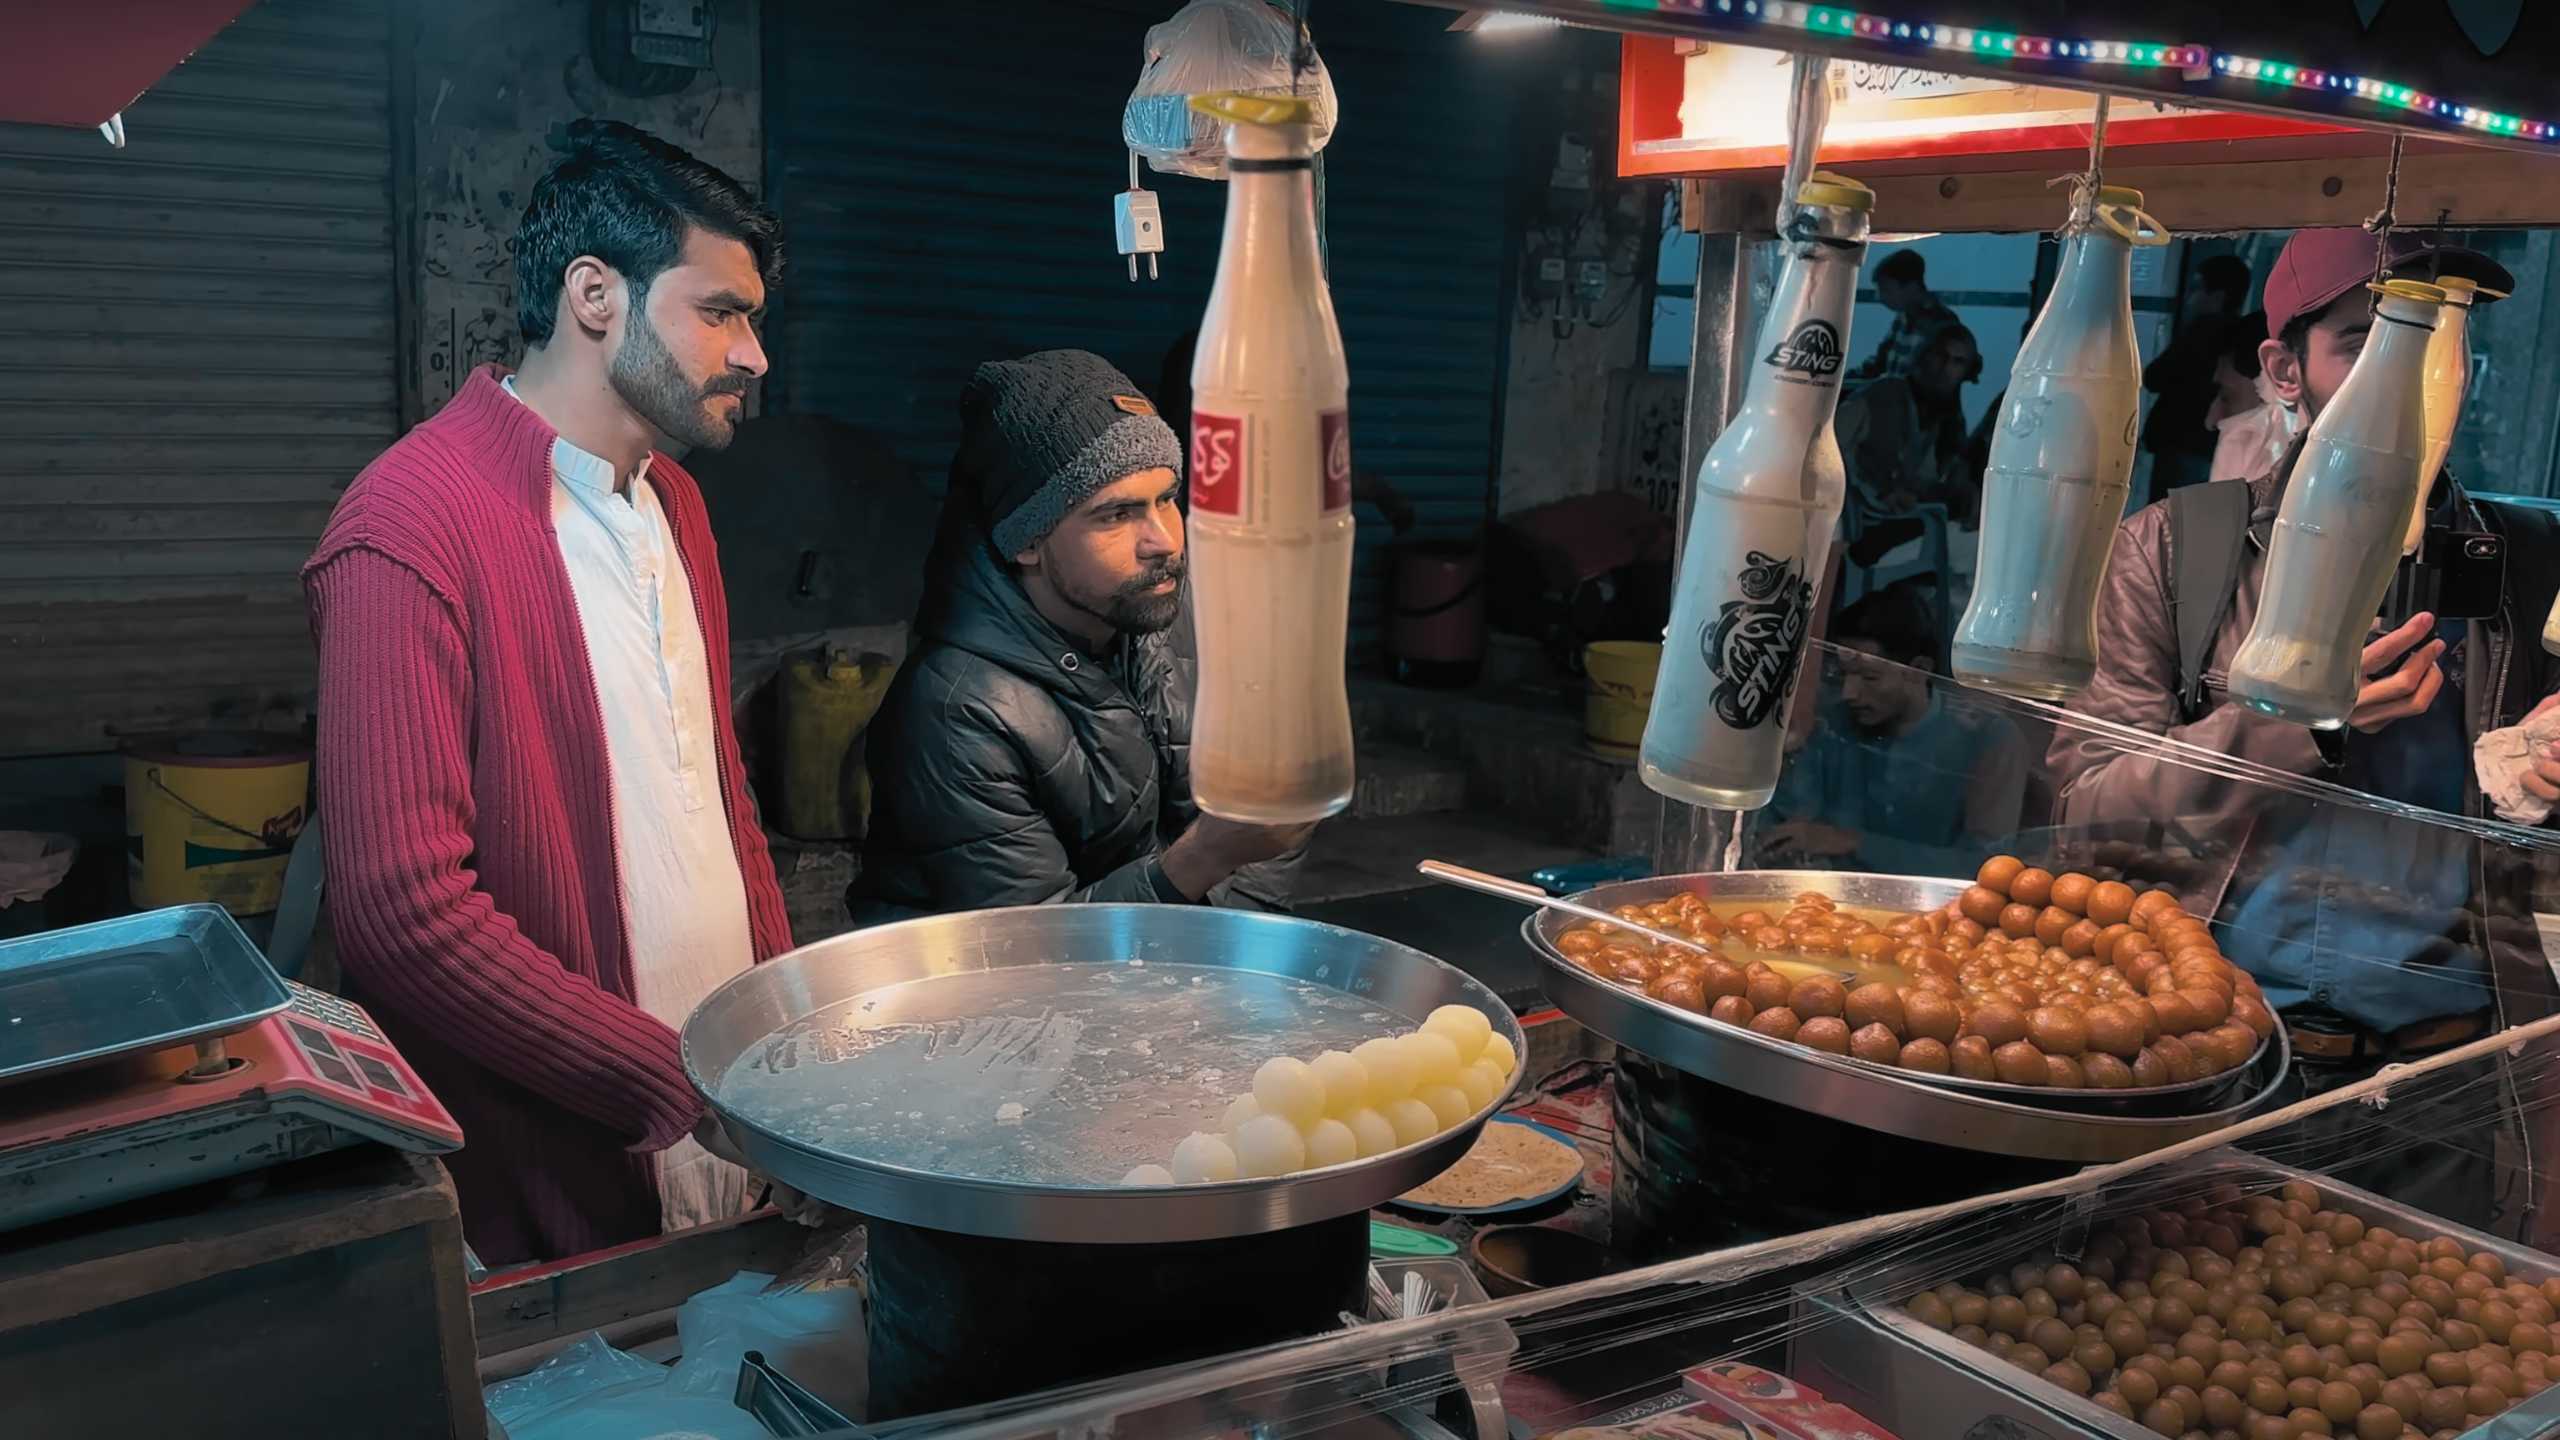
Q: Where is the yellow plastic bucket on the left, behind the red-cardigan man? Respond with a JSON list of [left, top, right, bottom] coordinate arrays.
[[125, 733, 312, 915]]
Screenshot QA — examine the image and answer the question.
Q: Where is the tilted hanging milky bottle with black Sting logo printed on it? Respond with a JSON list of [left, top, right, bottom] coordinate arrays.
[[1636, 174, 1876, 810]]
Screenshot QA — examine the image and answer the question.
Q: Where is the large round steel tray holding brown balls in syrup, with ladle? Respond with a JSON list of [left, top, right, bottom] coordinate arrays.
[[1521, 871, 2294, 1163]]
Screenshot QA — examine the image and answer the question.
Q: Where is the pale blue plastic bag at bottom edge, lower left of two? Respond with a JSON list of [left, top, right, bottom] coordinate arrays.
[[481, 1335, 773, 1440]]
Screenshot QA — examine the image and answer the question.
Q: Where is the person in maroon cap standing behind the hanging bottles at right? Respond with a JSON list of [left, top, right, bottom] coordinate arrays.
[[2048, 231, 2560, 1240]]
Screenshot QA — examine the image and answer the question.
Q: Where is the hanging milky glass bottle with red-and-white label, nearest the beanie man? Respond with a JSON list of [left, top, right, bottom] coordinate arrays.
[[1190, 95, 1352, 825]]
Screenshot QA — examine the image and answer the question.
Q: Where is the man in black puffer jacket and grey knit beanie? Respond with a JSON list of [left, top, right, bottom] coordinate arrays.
[[845, 351, 1311, 925]]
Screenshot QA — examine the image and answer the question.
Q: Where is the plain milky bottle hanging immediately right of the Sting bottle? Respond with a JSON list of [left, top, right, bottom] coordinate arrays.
[[1948, 187, 2168, 700]]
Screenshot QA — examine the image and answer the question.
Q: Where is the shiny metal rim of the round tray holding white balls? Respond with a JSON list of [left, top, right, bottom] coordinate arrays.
[[684, 904, 1528, 1245]]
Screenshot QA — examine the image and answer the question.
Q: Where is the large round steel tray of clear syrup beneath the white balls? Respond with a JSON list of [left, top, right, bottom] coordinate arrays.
[[684, 904, 1528, 1243]]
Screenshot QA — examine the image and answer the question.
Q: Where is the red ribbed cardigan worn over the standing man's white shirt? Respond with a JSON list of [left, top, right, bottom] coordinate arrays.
[[302, 369, 791, 1266]]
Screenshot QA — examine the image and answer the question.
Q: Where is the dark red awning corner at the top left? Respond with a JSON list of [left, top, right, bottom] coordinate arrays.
[[0, 0, 251, 128]]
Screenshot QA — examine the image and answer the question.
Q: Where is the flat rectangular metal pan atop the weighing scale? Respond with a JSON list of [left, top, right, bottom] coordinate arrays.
[[0, 904, 294, 1084]]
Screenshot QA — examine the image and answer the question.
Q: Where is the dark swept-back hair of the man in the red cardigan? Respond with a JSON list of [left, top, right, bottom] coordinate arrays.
[[515, 120, 783, 346]]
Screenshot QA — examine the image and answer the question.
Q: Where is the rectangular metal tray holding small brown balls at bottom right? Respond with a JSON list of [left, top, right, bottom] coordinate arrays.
[[1789, 1150, 2560, 1440]]
